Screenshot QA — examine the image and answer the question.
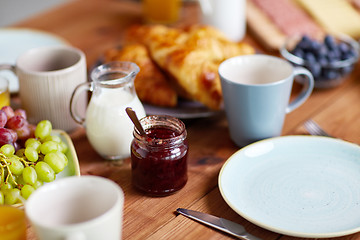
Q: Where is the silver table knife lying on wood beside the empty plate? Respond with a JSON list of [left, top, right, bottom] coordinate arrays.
[[176, 208, 261, 240]]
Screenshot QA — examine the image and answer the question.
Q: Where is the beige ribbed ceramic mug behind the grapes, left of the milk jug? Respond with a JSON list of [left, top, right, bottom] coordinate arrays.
[[0, 46, 87, 132]]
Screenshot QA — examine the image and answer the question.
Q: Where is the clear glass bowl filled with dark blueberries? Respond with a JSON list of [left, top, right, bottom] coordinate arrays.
[[280, 35, 360, 88]]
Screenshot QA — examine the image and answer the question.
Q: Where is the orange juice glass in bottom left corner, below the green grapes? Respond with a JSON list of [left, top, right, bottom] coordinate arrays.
[[0, 205, 26, 240]]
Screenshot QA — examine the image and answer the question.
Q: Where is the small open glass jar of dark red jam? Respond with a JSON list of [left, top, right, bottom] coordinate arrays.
[[131, 116, 188, 196]]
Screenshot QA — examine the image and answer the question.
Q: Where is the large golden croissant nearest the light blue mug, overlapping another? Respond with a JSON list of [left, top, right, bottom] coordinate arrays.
[[128, 25, 255, 110]]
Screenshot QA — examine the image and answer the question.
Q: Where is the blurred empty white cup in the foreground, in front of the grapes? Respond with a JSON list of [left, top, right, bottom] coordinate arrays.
[[25, 176, 124, 240]]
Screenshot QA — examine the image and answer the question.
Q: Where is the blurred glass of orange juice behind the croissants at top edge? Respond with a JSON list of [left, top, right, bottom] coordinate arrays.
[[142, 0, 181, 24]]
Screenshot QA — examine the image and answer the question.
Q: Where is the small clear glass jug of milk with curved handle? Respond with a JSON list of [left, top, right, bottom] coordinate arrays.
[[70, 62, 146, 160]]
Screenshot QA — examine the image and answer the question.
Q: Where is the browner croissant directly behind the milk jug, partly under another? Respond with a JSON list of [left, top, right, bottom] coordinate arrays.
[[105, 44, 178, 107]]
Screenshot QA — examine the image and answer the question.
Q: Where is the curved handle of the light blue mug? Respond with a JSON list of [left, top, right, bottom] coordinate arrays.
[[285, 67, 314, 113]]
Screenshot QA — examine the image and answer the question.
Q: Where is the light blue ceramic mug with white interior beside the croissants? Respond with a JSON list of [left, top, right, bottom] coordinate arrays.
[[219, 54, 314, 147]]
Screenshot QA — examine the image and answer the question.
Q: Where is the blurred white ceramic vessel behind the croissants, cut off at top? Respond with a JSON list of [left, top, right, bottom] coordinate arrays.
[[199, 0, 246, 41]]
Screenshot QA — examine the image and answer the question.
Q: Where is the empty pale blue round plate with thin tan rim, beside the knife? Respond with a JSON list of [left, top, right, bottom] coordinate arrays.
[[219, 136, 360, 238]]
